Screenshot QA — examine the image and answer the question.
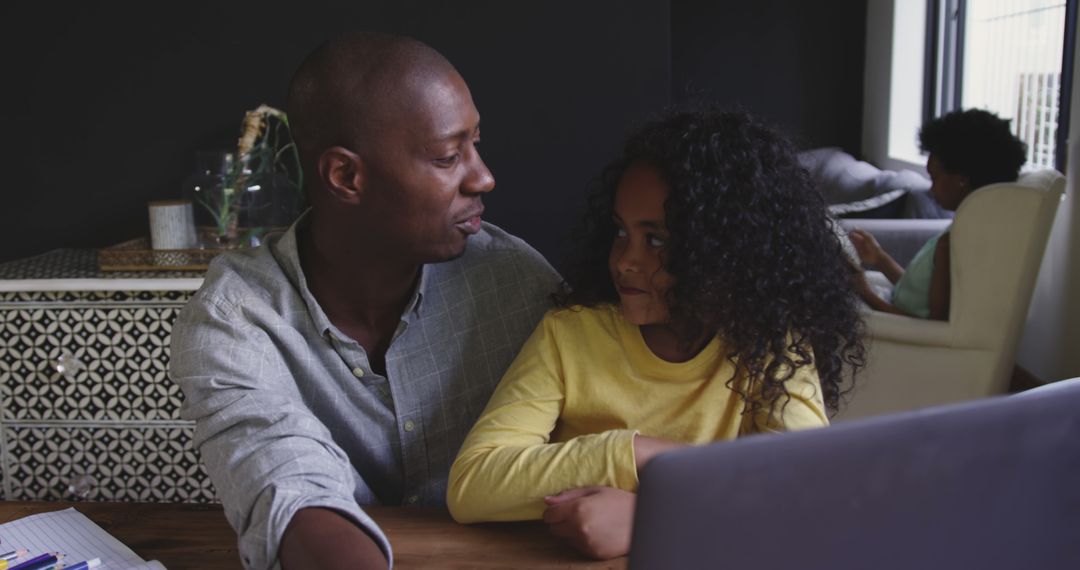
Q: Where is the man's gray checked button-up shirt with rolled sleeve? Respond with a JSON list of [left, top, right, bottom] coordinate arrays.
[[170, 215, 559, 568]]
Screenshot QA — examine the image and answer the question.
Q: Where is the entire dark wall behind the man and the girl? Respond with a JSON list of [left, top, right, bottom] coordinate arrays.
[[0, 0, 866, 264]]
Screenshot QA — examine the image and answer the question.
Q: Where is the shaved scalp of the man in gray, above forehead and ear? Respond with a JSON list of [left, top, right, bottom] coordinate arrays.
[[288, 32, 457, 179]]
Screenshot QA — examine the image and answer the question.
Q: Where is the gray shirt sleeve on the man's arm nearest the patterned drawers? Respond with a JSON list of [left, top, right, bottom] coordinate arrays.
[[170, 296, 390, 568]]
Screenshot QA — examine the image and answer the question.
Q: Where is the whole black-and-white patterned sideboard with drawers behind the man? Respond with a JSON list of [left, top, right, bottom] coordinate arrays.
[[0, 249, 215, 503]]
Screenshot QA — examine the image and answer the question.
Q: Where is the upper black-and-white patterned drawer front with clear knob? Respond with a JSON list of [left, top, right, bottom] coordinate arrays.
[[0, 303, 183, 420]]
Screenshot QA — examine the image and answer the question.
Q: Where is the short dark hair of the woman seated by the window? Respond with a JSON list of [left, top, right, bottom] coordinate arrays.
[[919, 109, 1027, 189]]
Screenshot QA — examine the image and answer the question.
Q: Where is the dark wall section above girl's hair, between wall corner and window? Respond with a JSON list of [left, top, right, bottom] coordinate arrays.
[[671, 0, 866, 154]]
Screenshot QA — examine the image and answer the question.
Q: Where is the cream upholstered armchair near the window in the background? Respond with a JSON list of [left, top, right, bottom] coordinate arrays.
[[837, 169, 1065, 420]]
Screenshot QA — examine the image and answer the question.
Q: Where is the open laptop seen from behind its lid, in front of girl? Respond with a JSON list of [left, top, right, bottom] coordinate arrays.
[[630, 379, 1080, 570]]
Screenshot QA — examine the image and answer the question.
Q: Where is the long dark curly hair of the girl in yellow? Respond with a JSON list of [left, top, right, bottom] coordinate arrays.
[[556, 110, 864, 413]]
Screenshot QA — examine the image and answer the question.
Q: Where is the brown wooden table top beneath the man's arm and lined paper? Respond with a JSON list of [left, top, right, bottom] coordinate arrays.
[[0, 501, 626, 570]]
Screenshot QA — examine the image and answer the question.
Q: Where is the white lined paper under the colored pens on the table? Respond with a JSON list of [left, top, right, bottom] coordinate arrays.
[[0, 508, 165, 570]]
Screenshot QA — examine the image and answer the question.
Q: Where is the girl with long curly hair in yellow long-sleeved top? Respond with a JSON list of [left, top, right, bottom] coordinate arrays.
[[447, 112, 863, 558]]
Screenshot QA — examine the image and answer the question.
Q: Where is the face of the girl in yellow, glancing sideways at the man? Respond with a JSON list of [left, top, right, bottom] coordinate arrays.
[[608, 163, 675, 325]]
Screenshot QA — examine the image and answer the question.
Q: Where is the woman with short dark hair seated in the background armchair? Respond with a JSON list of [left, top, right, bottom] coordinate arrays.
[[848, 109, 1027, 321]]
